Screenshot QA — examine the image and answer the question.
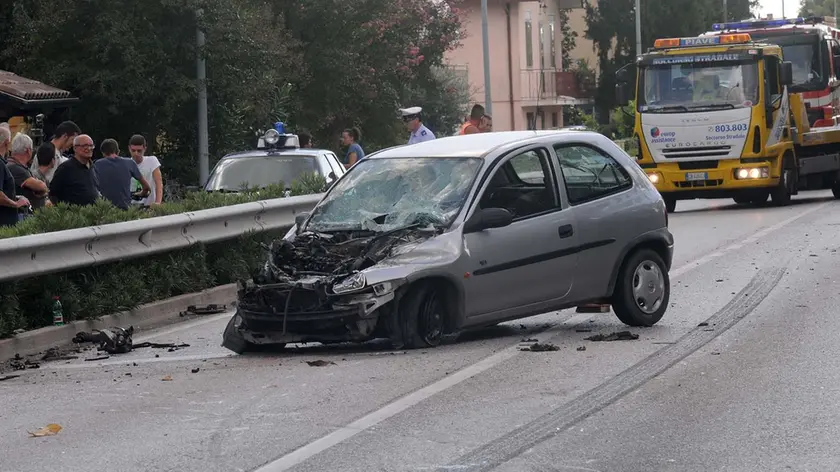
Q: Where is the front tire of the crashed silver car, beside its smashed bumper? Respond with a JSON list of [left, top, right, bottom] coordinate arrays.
[[391, 283, 446, 349]]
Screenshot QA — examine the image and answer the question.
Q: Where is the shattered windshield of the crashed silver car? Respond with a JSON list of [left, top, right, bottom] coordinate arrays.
[[306, 157, 482, 232]]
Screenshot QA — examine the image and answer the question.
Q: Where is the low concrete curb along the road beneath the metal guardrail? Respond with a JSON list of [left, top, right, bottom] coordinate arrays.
[[0, 284, 237, 362]]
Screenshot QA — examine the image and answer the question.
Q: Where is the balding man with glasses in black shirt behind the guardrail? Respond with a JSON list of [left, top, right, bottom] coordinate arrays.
[[50, 134, 99, 205]]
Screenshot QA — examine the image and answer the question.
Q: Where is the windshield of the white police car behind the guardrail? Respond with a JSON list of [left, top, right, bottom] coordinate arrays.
[[205, 154, 318, 191]]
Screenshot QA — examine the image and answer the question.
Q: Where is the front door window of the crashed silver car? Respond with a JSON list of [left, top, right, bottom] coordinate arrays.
[[479, 148, 560, 220]]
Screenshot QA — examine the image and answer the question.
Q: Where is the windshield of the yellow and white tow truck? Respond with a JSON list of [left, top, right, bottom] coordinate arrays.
[[637, 56, 758, 113]]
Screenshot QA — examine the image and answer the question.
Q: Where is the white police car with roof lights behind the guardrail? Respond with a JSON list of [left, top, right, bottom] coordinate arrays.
[[204, 123, 345, 192]]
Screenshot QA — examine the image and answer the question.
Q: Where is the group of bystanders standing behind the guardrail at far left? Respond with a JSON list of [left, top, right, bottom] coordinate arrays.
[[0, 121, 163, 226]]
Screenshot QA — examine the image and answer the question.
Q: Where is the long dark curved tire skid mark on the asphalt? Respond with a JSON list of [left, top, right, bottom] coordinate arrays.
[[450, 268, 785, 472]]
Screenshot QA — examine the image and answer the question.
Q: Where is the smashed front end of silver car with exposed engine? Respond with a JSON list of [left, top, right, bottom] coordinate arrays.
[[223, 227, 435, 351]]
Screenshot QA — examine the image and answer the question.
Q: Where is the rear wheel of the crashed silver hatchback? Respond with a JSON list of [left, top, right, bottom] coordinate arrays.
[[612, 249, 671, 326]]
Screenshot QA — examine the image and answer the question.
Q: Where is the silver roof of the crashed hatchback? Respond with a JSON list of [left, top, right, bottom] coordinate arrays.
[[365, 129, 603, 159]]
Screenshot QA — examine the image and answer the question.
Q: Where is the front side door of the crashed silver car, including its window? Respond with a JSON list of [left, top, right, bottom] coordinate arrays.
[[464, 146, 578, 324]]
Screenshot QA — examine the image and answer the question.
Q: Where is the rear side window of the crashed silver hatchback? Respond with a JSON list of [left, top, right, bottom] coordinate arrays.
[[554, 144, 633, 205]]
